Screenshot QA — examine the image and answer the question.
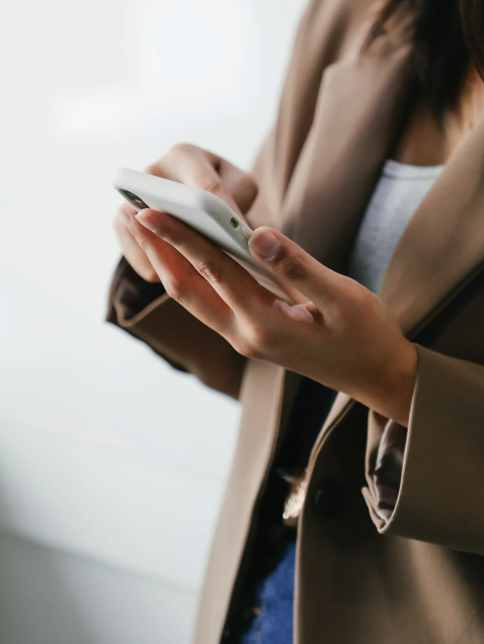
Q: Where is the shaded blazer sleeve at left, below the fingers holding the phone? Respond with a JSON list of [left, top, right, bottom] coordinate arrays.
[[106, 257, 245, 398]]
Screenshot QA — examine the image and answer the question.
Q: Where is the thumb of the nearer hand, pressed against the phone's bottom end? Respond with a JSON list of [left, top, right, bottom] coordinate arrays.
[[249, 227, 341, 302]]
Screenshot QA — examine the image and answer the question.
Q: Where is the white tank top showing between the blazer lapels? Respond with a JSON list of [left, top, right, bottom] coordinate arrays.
[[348, 161, 444, 293]]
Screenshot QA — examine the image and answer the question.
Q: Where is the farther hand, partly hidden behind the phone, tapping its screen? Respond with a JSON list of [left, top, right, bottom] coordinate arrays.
[[114, 143, 257, 282]]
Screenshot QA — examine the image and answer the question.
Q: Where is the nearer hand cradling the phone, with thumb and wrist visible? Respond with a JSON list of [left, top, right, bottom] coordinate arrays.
[[129, 210, 417, 426]]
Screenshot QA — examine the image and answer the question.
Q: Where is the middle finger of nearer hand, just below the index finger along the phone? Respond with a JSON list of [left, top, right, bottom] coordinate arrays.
[[126, 211, 233, 336]]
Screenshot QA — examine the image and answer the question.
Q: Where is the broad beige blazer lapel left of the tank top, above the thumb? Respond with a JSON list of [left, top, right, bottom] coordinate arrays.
[[282, 27, 413, 270]]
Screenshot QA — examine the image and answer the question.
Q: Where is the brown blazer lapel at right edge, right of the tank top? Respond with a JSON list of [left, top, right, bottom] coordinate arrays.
[[380, 115, 484, 337]]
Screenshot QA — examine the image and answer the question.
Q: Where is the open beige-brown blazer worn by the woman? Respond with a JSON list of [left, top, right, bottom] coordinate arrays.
[[109, 0, 484, 644]]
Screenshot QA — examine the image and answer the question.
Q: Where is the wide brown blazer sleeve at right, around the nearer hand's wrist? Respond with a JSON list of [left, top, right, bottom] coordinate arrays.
[[363, 346, 484, 555]]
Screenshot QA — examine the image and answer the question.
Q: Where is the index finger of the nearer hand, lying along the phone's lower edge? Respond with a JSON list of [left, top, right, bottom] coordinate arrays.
[[136, 210, 277, 316]]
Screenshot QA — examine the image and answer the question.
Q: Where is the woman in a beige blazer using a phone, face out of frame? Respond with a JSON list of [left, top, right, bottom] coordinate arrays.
[[109, 0, 484, 644]]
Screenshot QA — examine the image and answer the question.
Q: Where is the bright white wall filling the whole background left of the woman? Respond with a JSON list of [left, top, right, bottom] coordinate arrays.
[[0, 0, 302, 644]]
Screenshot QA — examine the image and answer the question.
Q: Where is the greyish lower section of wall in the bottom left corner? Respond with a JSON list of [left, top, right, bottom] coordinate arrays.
[[0, 533, 196, 644]]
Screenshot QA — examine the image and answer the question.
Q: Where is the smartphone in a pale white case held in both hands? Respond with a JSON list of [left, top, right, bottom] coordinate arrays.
[[114, 168, 291, 302]]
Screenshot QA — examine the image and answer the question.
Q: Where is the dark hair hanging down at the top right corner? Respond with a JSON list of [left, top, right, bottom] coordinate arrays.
[[372, 0, 484, 119]]
